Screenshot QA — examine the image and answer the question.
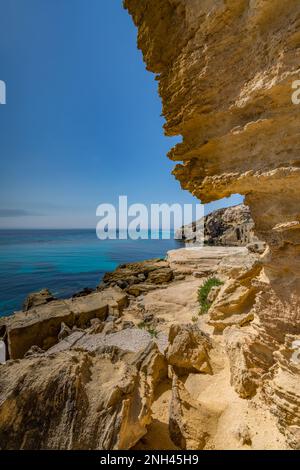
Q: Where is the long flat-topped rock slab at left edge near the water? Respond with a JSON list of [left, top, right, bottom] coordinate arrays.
[[0, 288, 128, 359]]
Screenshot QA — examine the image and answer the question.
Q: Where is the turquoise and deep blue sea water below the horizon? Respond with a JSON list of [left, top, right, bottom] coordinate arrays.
[[0, 230, 182, 316]]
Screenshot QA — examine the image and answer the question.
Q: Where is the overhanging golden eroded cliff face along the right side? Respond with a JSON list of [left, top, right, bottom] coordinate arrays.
[[124, 0, 300, 446]]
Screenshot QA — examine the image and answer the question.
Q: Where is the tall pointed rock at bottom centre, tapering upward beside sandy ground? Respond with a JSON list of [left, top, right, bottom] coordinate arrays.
[[169, 374, 216, 450]]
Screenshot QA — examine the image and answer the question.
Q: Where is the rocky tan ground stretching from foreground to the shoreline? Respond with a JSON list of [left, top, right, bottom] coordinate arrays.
[[0, 247, 299, 449]]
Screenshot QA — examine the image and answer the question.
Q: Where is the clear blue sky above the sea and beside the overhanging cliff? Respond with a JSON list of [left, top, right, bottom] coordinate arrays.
[[0, 0, 240, 228]]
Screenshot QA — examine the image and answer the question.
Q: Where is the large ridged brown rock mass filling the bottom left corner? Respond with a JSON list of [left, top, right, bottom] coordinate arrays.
[[0, 345, 166, 450]]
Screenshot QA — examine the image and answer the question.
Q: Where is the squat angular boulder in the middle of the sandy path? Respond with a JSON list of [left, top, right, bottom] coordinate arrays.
[[166, 324, 212, 375]]
